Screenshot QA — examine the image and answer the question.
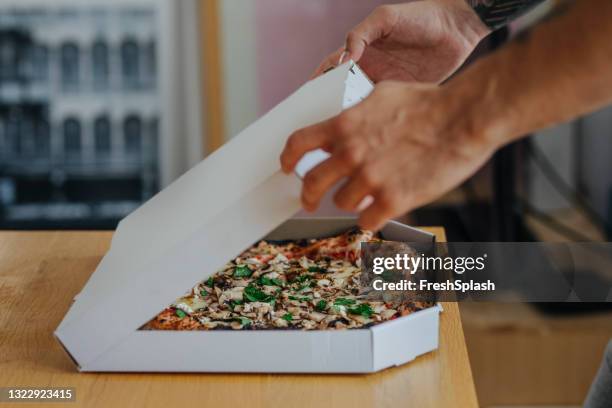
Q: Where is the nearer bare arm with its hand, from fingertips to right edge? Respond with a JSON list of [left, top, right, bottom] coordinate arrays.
[[281, 0, 612, 229]]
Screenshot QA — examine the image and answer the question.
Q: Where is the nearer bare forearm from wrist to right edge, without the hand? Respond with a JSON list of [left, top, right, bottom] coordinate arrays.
[[444, 0, 612, 147]]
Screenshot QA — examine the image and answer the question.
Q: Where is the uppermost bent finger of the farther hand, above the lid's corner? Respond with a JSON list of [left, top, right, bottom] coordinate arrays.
[[344, 6, 396, 62]]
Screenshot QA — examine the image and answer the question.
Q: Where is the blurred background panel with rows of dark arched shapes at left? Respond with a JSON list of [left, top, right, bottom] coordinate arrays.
[[0, 0, 172, 228]]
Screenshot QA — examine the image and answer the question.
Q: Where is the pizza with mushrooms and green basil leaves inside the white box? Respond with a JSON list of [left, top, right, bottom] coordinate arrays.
[[141, 228, 431, 330]]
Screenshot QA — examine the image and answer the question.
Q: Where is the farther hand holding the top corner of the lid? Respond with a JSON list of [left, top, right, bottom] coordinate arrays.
[[314, 0, 490, 83]]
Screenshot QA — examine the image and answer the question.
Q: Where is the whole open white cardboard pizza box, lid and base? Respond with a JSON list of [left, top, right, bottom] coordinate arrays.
[[55, 62, 441, 373]]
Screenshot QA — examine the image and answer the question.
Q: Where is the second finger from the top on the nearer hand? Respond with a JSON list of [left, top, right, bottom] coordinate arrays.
[[302, 149, 360, 211]]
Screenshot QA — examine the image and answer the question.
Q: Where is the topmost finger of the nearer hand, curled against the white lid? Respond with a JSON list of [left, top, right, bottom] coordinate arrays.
[[280, 119, 333, 174]]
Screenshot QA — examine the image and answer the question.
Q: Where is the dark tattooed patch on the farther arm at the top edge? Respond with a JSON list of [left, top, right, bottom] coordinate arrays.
[[467, 0, 544, 30]]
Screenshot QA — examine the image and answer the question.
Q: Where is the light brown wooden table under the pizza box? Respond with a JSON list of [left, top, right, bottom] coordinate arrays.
[[0, 228, 477, 408]]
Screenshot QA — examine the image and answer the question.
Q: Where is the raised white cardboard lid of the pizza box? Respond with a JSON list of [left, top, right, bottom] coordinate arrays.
[[55, 62, 437, 371]]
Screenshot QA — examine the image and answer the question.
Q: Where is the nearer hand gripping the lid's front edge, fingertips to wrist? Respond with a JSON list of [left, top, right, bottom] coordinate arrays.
[[281, 82, 493, 229]]
